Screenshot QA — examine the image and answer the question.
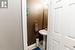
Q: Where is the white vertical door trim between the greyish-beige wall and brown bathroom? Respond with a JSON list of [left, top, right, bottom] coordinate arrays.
[[22, 0, 28, 50]]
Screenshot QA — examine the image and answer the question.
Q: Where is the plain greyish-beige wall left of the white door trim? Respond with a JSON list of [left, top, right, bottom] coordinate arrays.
[[0, 0, 23, 50]]
